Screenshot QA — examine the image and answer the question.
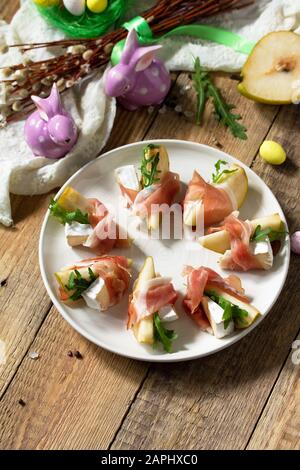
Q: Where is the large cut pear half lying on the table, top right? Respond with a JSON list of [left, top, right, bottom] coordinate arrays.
[[238, 31, 300, 104]]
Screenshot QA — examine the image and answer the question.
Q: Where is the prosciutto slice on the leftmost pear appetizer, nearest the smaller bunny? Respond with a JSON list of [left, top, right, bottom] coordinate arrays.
[[83, 199, 118, 254]]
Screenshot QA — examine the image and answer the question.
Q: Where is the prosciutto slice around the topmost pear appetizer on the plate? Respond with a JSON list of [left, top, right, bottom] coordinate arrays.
[[133, 171, 180, 217]]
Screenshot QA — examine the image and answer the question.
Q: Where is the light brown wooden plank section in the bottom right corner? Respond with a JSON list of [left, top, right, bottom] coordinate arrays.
[[247, 335, 300, 450]]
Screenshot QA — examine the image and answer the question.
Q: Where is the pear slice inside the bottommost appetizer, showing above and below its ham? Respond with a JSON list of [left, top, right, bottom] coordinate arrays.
[[132, 256, 156, 344]]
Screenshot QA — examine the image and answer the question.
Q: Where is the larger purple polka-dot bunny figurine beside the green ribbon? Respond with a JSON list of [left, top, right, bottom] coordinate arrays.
[[105, 29, 171, 111]]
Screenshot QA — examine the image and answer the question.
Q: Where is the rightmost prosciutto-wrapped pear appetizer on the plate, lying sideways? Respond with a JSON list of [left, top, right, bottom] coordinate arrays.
[[199, 214, 286, 271]]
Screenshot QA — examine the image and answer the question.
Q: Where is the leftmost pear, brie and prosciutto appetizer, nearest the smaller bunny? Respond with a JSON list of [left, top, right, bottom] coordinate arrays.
[[49, 186, 130, 254]]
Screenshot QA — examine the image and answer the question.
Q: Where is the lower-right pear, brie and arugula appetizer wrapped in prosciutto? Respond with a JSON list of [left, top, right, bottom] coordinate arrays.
[[183, 266, 260, 338]]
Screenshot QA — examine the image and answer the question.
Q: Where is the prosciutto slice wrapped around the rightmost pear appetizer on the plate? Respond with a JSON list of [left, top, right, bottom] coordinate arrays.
[[211, 214, 264, 271]]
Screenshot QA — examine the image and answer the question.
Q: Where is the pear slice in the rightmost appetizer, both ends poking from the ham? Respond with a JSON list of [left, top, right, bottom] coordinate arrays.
[[198, 214, 283, 254]]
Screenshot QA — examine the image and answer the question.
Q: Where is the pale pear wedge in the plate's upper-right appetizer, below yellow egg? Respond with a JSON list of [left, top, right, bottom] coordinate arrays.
[[215, 164, 248, 209]]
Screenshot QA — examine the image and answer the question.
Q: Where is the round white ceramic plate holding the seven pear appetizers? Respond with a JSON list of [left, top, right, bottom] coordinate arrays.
[[39, 140, 290, 362]]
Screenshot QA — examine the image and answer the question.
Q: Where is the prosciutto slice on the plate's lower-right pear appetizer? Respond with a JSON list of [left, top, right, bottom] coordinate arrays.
[[182, 266, 249, 330]]
